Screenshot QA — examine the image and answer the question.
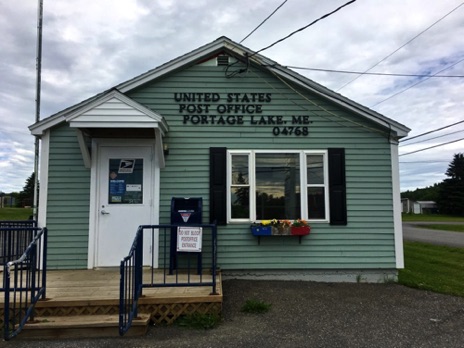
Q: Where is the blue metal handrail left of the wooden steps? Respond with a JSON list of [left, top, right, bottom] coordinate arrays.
[[0, 227, 47, 341]]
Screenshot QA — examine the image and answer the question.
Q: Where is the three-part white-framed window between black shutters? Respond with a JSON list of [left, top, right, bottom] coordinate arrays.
[[228, 150, 329, 222]]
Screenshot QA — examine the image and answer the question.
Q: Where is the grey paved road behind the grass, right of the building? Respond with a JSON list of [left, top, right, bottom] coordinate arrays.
[[403, 222, 464, 248]]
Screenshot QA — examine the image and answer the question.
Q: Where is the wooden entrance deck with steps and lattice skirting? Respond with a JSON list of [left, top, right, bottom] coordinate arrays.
[[0, 269, 223, 338]]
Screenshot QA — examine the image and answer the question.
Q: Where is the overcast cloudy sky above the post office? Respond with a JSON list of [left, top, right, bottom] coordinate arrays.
[[0, 0, 464, 192]]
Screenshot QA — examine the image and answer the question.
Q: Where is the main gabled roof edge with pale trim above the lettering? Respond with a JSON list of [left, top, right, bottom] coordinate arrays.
[[29, 37, 410, 138]]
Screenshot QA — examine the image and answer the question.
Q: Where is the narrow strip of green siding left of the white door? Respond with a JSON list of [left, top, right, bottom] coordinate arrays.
[[46, 125, 90, 269]]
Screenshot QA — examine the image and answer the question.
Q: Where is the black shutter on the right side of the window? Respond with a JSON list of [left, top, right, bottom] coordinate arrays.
[[329, 148, 348, 225]]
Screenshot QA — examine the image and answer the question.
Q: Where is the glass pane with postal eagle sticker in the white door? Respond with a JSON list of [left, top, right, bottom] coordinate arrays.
[[108, 158, 143, 204]]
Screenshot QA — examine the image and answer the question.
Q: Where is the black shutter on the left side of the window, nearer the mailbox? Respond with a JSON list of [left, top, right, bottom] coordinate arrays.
[[209, 147, 227, 225]]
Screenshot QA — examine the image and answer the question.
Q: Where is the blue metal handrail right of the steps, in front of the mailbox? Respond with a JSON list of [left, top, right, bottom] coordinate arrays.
[[119, 224, 217, 336]]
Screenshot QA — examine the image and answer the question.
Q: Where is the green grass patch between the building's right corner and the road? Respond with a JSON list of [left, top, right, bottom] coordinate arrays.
[[398, 242, 464, 296]]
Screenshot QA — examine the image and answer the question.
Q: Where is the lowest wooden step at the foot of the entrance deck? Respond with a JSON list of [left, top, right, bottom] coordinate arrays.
[[18, 314, 150, 339]]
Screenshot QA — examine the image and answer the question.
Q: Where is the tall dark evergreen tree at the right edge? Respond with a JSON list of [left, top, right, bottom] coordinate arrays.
[[437, 153, 464, 216]]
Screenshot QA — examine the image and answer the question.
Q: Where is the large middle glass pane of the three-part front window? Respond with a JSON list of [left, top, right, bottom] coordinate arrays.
[[255, 153, 301, 220]]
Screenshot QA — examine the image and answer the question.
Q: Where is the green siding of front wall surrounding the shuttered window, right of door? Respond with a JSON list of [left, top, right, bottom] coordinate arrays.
[[128, 61, 396, 270]]
